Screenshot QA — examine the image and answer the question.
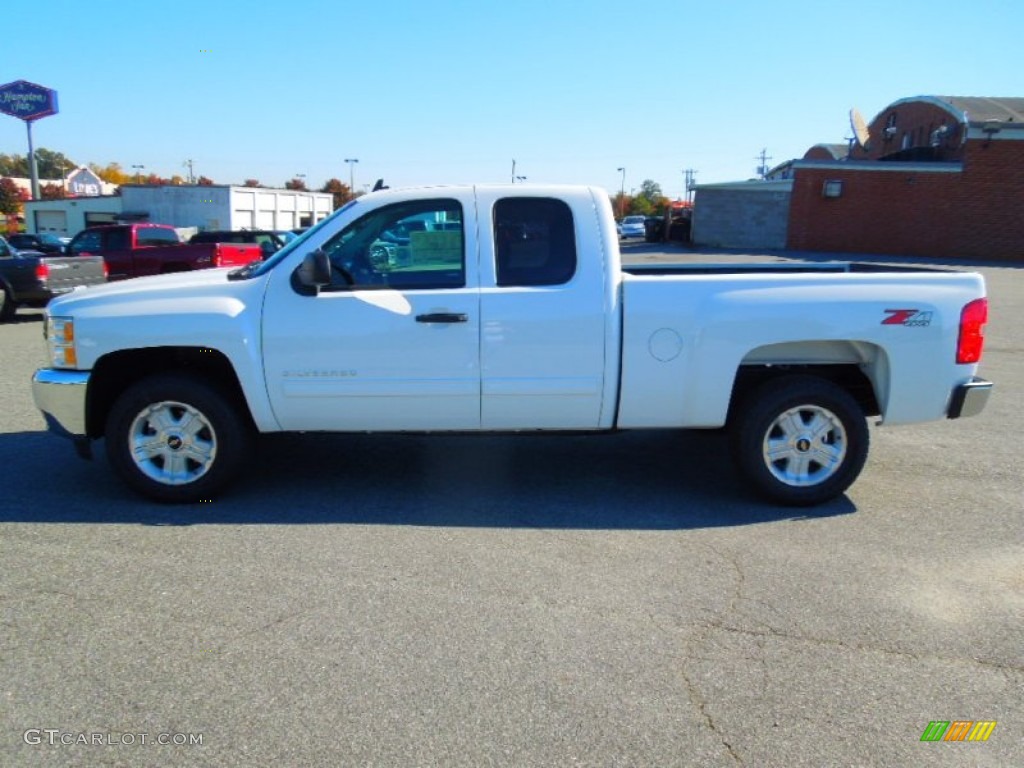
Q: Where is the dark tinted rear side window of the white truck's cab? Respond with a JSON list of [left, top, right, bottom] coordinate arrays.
[[494, 198, 577, 286]]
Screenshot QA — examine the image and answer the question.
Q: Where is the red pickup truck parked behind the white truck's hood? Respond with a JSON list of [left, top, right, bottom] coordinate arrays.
[[68, 224, 263, 281]]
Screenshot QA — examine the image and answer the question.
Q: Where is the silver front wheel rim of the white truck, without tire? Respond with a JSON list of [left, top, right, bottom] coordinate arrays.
[[128, 400, 217, 485]]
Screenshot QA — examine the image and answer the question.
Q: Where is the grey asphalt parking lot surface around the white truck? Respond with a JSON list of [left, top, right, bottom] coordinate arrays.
[[0, 244, 1024, 767]]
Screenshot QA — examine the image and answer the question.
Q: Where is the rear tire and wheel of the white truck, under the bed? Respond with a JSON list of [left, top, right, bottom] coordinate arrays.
[[730, 376, 870, 507]]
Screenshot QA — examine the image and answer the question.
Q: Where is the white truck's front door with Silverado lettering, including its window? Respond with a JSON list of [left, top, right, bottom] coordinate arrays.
[[263, 198, 480, 431]]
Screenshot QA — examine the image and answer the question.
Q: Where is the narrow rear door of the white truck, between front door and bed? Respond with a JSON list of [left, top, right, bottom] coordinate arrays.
[[477, 189, 617, 430]]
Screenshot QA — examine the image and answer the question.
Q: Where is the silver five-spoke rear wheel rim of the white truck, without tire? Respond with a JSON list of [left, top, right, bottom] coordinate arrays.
[[762, 404, 848, 487]]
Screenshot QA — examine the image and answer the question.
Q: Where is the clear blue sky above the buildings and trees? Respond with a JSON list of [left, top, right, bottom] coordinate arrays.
[[0, 0, 1024, 198]]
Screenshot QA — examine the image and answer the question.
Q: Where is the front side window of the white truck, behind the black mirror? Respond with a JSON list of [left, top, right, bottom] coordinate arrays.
[[324, 200, 466, 290]]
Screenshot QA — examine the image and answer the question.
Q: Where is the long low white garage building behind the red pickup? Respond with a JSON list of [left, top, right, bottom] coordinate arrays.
[[25, 184, 334, 236]]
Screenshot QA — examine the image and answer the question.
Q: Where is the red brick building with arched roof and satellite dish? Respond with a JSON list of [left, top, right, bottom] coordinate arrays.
[[787, 96, 1024, 262]]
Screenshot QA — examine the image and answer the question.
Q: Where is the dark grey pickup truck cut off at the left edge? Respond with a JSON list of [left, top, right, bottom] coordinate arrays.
[[0, 238, 106, 323]]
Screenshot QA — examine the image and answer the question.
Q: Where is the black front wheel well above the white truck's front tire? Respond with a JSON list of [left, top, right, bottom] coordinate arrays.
[[86, 347, 249, 437]]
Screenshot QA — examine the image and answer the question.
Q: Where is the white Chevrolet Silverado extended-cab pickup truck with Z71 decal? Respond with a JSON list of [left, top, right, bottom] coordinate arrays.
[[33, 184, 992, 505]]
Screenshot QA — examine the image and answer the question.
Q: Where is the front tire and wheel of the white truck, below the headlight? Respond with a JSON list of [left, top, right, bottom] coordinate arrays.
[[105, 374, 253, 504]]
